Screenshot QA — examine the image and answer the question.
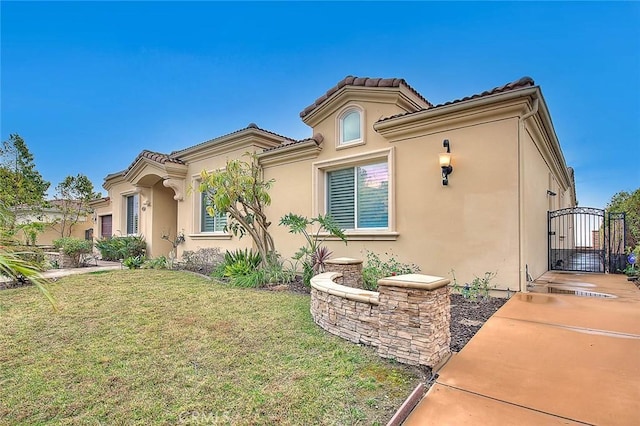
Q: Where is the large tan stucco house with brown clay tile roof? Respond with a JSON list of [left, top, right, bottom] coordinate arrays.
[[93, 77, 576, 291]]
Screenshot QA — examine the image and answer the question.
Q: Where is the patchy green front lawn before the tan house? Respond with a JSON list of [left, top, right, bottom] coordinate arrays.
[[0, 270, 420, 425]]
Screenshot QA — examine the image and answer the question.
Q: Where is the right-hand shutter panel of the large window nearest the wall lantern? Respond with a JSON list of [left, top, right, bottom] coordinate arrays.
[[357, 163, 389, 228]]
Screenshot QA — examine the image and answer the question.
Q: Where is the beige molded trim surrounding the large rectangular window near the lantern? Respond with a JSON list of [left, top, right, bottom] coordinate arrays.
[[312, 147, 399, 241]]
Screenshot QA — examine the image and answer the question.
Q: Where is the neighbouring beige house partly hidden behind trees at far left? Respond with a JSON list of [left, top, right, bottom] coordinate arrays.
[[14, 200, 93, 247]]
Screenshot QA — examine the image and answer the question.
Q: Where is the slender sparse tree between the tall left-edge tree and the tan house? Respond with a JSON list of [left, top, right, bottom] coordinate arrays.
[[54, 174, 101, 237]]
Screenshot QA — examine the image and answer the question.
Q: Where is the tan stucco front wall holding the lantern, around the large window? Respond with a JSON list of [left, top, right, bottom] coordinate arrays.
[[266, 103, 519, 290]]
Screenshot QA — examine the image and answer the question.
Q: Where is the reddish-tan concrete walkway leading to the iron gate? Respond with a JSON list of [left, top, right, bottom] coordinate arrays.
[[404, 272, 640, 425]]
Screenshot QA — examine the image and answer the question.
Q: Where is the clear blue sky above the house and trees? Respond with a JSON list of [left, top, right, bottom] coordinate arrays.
[[0, 1, 640, 207]]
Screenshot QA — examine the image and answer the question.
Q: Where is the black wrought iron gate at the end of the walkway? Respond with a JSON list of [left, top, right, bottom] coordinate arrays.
[[548, 207, 626, 273]]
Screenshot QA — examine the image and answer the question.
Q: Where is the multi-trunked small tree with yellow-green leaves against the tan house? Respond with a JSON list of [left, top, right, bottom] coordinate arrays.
[[199, 153, 276, 264]]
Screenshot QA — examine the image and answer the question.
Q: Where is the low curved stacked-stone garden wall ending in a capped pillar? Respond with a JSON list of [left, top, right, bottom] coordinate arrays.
[[311, 272, 451, 367]]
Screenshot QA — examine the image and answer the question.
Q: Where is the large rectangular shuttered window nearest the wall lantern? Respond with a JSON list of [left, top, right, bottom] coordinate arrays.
[[326, 161, 389, 229]]
